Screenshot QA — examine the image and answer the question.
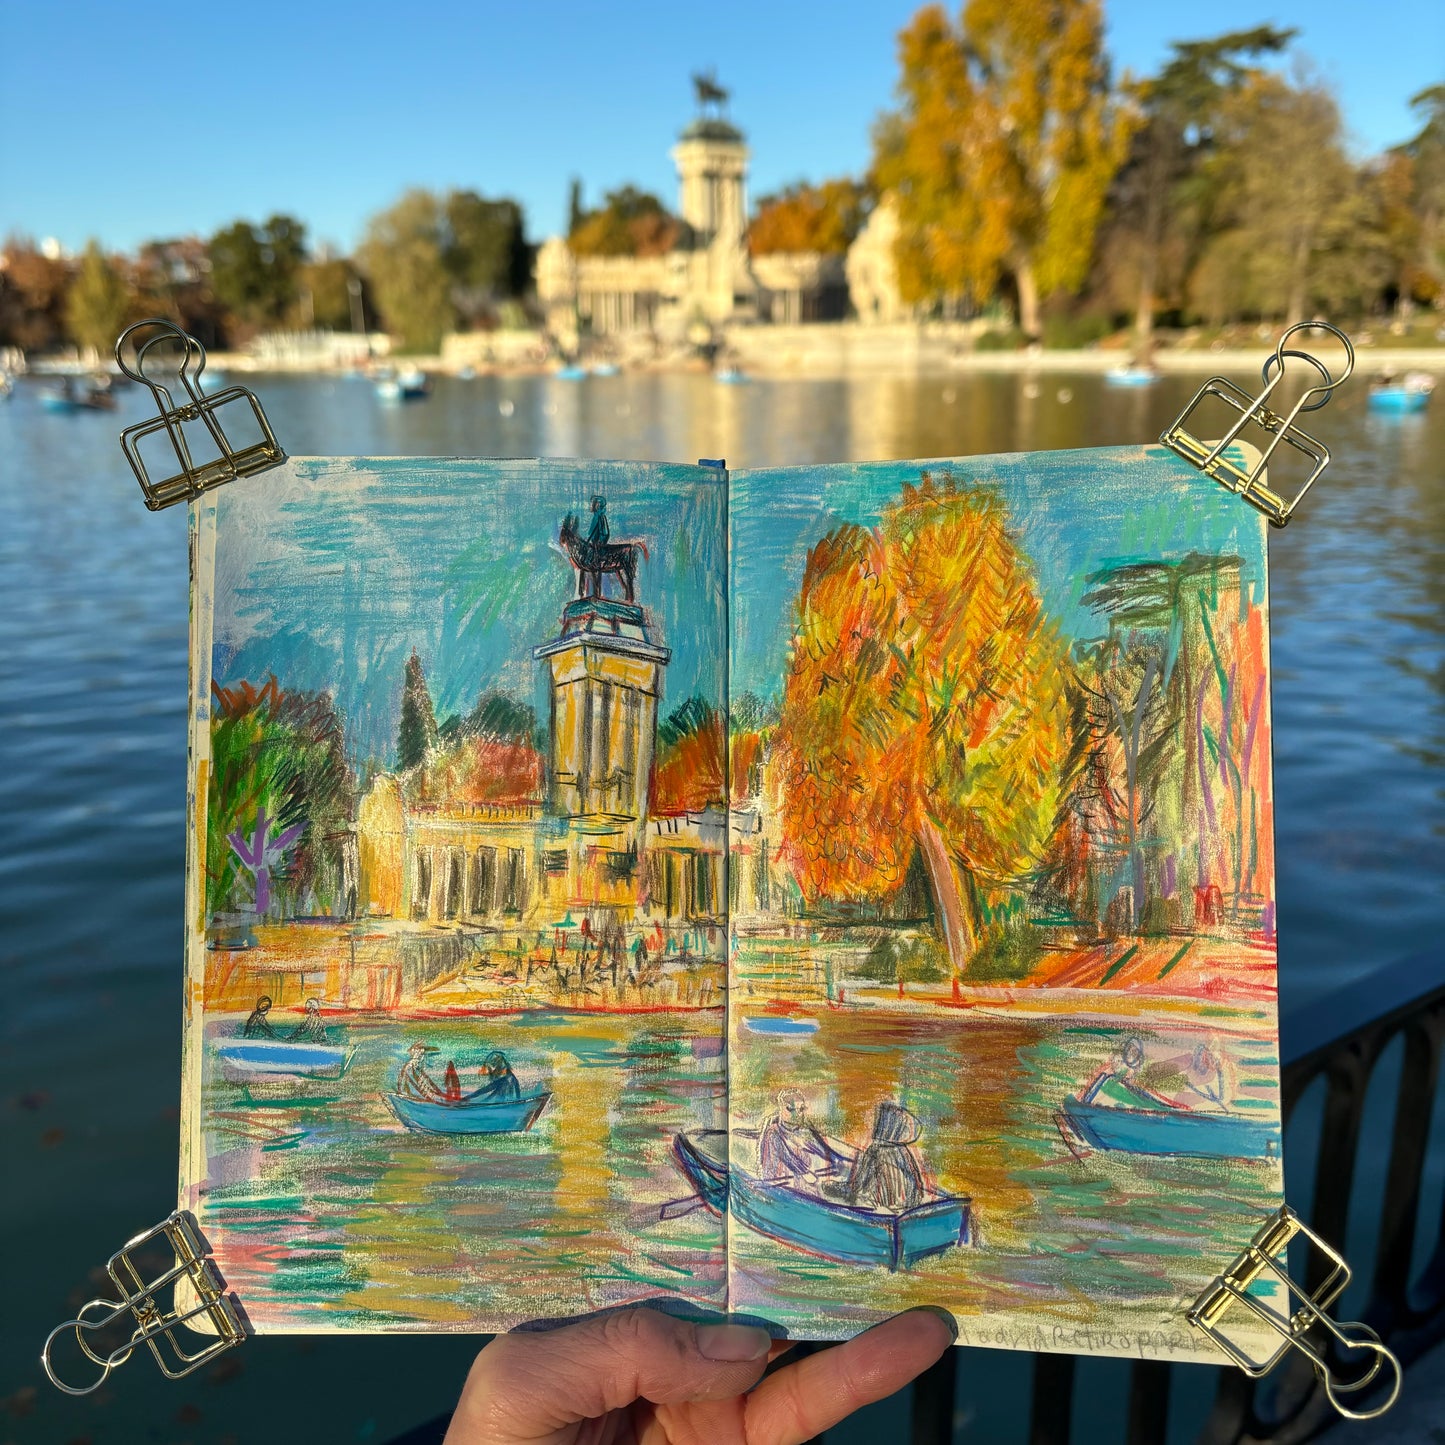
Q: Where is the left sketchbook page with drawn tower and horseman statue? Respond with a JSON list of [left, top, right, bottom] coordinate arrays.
[[181, 458, 727, 1331]]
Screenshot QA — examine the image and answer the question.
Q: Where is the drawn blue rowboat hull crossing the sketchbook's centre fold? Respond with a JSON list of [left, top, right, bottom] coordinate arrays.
[[672, 1129, 972, 1270]]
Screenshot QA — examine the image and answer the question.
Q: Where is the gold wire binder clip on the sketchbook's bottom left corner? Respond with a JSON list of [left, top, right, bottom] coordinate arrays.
[[40, 1209, 246, 1394]]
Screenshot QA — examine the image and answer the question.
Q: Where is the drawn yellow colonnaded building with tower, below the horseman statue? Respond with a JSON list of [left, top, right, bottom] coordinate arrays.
[[357, 514, 727, 929]]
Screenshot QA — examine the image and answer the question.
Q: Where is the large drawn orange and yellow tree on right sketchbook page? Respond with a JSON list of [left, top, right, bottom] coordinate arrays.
[[775, 473, 1078, 975]]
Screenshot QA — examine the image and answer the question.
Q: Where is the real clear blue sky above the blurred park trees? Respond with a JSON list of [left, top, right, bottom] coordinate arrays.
[[0, 0, 1445, 249]]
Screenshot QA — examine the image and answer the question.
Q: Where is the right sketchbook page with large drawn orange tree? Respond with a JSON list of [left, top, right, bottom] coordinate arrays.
[[728, 448, 1282, 1358]]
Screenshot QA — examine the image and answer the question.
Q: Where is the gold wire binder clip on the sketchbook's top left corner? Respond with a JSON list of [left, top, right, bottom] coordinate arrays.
[[116, 316, 286, 512]]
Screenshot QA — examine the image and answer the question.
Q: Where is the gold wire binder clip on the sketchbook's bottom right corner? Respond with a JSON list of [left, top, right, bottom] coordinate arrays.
[[1185, 1205, 1402, 1420]]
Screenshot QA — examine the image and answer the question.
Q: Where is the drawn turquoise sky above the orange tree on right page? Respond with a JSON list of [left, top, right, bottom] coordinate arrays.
[[728, 447, 1269, 696]]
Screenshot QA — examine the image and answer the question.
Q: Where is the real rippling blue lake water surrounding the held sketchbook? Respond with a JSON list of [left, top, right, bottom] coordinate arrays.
[[0, 374, 1445, 1445]]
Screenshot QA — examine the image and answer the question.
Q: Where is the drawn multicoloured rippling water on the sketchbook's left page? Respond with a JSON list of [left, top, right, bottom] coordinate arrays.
[[198, 1013, 725, 1329]]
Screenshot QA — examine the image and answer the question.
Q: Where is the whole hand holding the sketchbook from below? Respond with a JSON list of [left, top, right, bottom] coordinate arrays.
[[445, 1309, 954, 1445]]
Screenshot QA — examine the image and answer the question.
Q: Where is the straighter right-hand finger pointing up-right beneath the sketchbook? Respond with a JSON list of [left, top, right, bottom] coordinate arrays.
[[747, 1309, 957, 1445]]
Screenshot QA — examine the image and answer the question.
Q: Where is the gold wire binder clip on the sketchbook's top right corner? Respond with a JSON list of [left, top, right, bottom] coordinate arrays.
[[1159, 321, 1354, 527]]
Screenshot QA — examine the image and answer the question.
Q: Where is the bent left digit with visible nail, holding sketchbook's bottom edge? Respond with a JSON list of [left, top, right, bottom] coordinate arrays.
[[445, 1309, 772, 1445]]
